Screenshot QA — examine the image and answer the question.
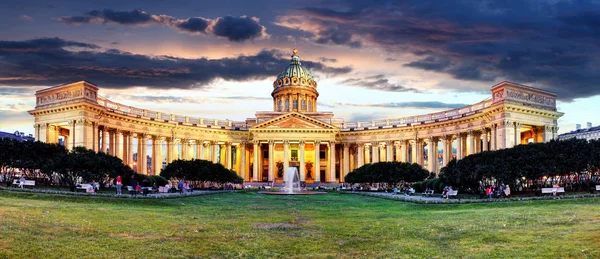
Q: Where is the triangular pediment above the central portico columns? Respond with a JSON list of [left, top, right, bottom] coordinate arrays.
[[252, 112, 336, 129]]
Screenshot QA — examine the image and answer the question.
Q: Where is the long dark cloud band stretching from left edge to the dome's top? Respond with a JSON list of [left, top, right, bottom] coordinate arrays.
[[0, 38, 351, 89]]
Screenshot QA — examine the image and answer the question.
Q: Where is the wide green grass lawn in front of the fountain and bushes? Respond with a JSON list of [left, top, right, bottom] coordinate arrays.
[[0, 191, 600, 258]]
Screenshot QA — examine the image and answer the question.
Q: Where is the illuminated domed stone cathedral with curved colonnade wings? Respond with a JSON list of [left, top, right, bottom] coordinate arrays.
[[29, 50, 563, 183]]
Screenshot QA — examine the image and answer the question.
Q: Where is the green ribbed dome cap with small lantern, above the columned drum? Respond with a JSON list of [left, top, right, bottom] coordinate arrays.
[[273, 49, 317, 88]]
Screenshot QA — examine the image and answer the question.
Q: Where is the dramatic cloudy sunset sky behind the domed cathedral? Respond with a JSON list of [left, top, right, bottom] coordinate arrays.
[[0, 0, 600, 134]]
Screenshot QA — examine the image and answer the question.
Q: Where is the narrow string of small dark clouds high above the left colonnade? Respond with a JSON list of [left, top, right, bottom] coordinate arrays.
[[58, 9, 269, 42]]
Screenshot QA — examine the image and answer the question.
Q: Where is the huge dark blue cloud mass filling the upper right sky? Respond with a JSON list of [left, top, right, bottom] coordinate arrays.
[[276, 0, 600, 101]]
